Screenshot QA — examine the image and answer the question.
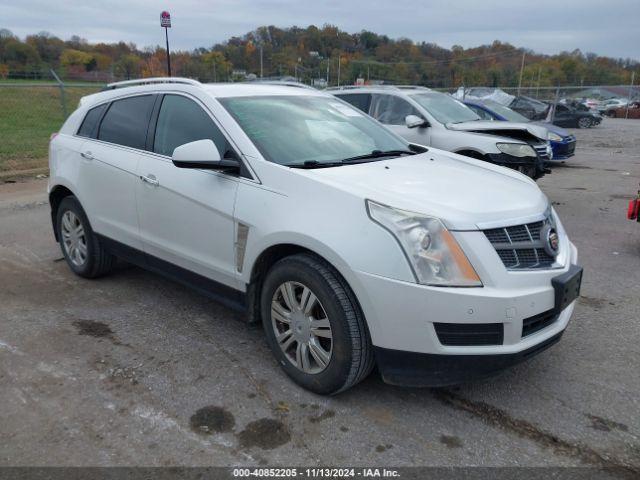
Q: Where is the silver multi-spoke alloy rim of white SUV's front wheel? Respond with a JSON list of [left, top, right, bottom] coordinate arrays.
[[271, 281, 333, 374]]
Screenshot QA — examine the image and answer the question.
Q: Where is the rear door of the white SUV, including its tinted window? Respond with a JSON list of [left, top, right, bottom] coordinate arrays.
[[77, 94, 156, 249]]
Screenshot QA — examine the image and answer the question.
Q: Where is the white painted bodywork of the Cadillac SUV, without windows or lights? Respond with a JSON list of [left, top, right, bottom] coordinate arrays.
[[49, 79, 577, 382]]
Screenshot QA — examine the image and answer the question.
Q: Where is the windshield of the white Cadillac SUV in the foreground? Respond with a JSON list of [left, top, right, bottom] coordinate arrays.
[[219, 95, 409, 165]]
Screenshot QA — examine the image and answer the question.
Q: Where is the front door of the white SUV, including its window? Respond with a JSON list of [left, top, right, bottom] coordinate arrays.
[[137, 94, 239, 287]]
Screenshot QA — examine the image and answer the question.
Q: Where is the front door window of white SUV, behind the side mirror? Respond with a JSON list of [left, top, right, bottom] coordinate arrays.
[[153, 95, 234, 157]]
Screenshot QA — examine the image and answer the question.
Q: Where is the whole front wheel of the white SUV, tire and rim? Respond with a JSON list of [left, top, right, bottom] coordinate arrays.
[[260, 254, 373, 395]]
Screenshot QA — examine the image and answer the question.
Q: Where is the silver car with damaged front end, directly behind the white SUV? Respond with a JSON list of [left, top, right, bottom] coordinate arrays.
[[329, 86, 551, 179]]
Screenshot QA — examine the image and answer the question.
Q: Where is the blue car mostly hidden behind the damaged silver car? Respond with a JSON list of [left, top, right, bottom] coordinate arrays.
[[464, 100, 576, 161]]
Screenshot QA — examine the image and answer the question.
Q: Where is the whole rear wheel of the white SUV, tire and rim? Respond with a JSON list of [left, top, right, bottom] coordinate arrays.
[[56, 196, 116, 278]]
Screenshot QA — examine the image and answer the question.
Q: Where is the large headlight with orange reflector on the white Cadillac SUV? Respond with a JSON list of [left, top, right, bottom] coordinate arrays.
[[367, 200, 482, 287]]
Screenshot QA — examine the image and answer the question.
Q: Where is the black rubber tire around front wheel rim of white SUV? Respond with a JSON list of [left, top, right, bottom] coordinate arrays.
[[260, 254, 374, 395]]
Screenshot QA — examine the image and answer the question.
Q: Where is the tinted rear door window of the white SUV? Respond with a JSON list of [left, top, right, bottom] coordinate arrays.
[[98, 95, 155, 149]]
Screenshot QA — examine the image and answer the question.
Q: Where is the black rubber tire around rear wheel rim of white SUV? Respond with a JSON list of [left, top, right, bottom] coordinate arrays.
[[56, 196, 116, 278]]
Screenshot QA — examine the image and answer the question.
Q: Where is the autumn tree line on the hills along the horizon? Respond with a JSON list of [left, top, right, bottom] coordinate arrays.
[[0, 25, 640, 88]]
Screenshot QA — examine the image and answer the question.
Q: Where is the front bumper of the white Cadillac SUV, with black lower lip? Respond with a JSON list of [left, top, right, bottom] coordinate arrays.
[[354, 232, 577, 386]]
